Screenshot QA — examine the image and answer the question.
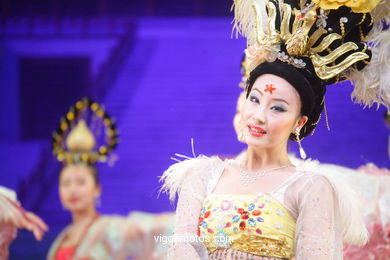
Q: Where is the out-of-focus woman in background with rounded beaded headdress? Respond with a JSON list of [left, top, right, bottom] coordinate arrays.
[[48, 98, 151, 260]]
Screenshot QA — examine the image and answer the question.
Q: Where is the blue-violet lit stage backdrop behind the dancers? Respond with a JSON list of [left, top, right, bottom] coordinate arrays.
[[0, 18, 389, 259]]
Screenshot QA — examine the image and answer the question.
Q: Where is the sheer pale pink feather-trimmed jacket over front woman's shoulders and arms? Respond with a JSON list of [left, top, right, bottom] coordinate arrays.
[[161, 156, 367, 260]]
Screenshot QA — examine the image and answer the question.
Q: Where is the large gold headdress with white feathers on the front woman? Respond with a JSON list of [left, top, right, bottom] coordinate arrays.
[[233, 0, 390, 108]]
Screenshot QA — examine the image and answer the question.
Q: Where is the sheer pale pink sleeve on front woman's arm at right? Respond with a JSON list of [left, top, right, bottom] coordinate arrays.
[[295, 176, 342, 260]]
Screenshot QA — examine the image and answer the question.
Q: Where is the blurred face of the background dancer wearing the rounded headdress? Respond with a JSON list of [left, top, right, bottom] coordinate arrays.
[[59, 165, 100, 212]]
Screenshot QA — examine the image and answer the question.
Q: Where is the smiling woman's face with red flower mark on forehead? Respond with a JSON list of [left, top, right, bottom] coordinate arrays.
[[242, 74, 307, 148]]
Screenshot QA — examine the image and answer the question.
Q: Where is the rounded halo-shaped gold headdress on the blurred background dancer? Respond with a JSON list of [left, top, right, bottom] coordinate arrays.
[[52, 98, 118, 164]]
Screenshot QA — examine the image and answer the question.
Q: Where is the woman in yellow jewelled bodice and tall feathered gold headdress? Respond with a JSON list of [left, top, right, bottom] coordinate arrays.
[[163, 0, 390, 260]]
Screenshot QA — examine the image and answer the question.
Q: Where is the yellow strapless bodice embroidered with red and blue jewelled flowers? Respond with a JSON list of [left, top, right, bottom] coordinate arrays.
[[198, 193, 295, 258]]
